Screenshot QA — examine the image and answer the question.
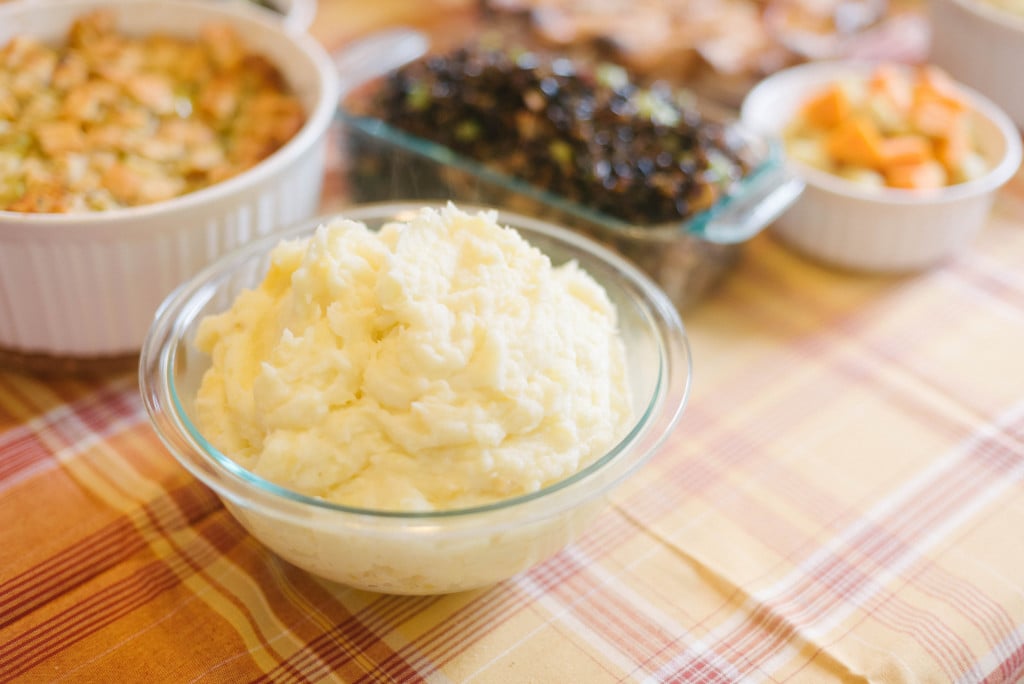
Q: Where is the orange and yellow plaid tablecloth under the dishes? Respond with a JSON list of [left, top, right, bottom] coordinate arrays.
[[0, 2, 1024, 682]]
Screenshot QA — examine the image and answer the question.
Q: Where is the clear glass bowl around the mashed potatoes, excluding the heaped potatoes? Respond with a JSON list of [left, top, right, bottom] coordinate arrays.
[[139, 203, 691, 594]]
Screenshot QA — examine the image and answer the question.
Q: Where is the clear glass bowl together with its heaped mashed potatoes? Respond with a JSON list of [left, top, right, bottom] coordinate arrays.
[[139, 204, 690, 594]]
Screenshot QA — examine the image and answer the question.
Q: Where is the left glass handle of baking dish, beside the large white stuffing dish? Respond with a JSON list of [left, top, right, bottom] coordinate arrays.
[[331, 28, 429, 96]]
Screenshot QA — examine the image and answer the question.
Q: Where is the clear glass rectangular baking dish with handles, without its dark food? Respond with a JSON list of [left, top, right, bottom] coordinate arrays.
[[335, 29, 803, 309]]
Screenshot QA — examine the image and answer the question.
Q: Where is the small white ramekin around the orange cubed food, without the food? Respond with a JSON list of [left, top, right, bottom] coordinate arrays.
[[741, 61, 1021, 271]]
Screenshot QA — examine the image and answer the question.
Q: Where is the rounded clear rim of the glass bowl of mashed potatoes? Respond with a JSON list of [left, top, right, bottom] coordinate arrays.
[[138, 202, 693, 522]]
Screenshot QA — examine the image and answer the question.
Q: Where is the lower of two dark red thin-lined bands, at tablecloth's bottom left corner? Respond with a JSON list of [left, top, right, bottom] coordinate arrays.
[[0, 511, 244, 680]]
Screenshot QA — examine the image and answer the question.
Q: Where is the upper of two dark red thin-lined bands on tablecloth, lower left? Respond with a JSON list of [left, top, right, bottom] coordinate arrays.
[[0, 484, 219, 628]]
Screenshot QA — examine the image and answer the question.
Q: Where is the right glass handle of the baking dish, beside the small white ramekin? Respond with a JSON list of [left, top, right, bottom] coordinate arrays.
[[694, 165, 804, 244]]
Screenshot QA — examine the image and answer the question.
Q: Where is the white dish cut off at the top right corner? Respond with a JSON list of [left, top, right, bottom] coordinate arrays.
[[929, 0, 1024, 128]]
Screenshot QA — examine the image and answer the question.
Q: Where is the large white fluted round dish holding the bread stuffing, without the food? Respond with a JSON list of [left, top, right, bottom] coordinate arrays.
[[0, 0, 338, 358]]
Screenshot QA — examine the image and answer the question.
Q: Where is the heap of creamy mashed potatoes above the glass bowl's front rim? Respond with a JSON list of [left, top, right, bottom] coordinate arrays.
[[197, 205, 631, 511]]
